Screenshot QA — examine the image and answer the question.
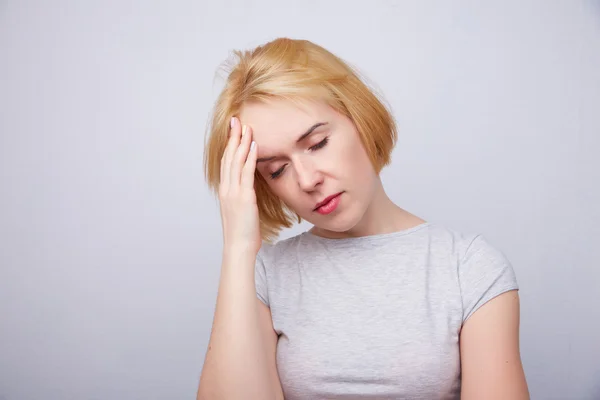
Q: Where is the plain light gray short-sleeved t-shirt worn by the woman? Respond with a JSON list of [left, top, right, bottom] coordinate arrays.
[[255, 223, 518, 400]]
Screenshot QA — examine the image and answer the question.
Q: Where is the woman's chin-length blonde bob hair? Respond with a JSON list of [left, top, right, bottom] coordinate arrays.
[[204, 38, 397, 242]]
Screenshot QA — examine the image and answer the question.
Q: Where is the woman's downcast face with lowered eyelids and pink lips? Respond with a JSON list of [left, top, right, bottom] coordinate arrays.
[[240, 100, 378, 232]]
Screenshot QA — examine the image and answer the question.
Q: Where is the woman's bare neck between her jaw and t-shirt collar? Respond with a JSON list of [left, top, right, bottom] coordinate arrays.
[[311, 179, 425, 239]]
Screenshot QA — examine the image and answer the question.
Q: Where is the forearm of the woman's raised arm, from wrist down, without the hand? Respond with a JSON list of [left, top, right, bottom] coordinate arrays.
[[198, 251, 275, 400]]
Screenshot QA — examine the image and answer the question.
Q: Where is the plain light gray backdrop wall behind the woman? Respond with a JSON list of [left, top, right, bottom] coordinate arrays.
[[0, 0, 600, 400]]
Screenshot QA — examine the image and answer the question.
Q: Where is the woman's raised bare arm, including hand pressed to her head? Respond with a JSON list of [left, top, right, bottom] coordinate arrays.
[[197, 122, 283, 400]]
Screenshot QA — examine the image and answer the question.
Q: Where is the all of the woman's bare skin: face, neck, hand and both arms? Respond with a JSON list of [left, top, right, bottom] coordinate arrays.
[[198, 101, 529, 400]]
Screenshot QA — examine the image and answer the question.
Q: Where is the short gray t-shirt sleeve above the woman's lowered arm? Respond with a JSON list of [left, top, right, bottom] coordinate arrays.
[[458, 235, 519, 322]]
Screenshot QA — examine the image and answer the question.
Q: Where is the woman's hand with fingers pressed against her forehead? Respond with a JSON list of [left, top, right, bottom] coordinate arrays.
[[219, 117, 262, 254]]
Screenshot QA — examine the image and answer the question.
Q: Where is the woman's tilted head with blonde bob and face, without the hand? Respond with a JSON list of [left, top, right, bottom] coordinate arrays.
[[205, 39, 397, 241]]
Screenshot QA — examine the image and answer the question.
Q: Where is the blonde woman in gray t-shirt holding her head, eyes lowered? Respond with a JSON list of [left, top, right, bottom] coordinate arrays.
[[198, 39, 529, 400]]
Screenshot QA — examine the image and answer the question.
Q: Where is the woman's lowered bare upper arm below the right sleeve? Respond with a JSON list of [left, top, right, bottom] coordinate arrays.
[[460, 290, 529, 400]]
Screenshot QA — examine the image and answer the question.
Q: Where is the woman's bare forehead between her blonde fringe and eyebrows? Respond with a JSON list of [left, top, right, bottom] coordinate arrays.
[[239, 100, 336, 145]]
